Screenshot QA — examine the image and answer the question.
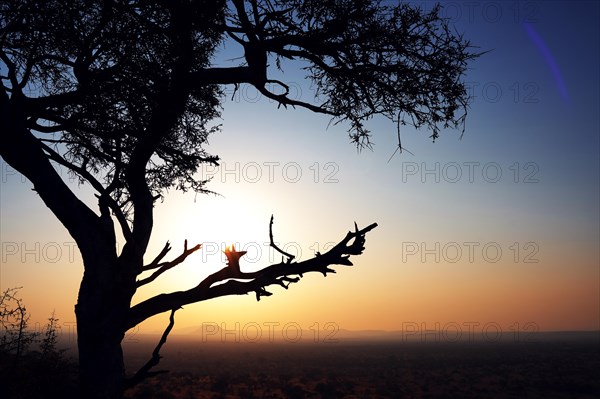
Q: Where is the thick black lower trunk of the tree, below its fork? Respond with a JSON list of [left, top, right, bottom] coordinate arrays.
[[75, 259, 133, 399]]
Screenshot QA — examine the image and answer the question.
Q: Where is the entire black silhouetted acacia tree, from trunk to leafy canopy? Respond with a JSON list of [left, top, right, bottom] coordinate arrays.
[[0, 0, 477, 398]]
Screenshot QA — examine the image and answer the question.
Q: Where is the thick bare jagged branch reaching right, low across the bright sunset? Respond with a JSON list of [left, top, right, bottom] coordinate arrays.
[[128, 223, 377, 328]]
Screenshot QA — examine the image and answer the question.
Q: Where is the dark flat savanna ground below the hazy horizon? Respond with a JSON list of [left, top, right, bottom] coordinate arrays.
[[0, 333, 600, 399]]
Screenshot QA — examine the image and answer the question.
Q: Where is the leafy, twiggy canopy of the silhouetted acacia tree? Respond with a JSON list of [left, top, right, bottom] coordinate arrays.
[[1, 0, 475, 220]]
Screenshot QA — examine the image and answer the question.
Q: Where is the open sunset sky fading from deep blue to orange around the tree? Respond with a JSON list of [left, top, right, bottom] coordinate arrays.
[[0, 1, 600, 340]]
